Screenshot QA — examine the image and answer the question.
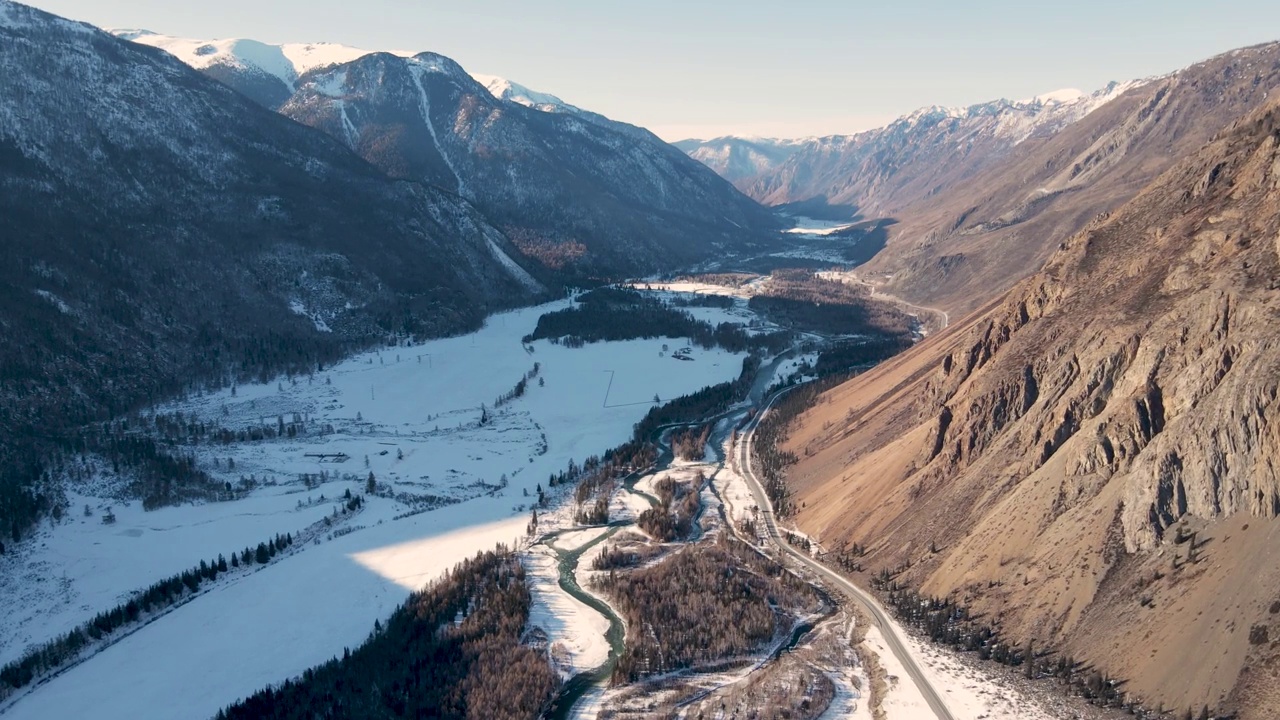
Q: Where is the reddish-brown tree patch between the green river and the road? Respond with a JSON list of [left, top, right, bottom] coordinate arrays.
[[596, 533, 822, 684]]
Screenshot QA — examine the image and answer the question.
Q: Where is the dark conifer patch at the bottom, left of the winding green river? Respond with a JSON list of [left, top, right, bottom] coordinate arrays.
[[218, 546, 561, 720]]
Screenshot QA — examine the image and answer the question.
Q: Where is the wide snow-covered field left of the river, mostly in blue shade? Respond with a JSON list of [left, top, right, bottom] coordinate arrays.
[[0, 295, 741, 719]]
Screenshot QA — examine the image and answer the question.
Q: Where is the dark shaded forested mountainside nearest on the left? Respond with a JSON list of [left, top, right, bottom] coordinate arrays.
[[0, 0, 539, 445]]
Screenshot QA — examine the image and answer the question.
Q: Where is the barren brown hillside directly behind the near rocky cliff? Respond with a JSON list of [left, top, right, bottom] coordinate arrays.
[[851, 44, 1280, 314]]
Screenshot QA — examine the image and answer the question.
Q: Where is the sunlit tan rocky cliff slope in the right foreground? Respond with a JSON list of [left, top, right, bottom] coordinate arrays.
[[788, 99, 1280, 719]]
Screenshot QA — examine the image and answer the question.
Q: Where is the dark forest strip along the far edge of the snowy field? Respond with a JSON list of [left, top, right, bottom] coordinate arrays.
[[524, 287, 788, 352]]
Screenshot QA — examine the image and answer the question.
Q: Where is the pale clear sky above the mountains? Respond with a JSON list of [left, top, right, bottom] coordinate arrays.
[[22, 0, 1280, 140]]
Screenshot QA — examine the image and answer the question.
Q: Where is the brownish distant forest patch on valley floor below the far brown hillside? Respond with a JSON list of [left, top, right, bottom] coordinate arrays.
[[748, 269, 914, 338]]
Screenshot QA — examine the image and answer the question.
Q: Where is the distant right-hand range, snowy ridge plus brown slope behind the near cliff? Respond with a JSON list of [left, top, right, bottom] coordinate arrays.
[[686, 45, 1280, 316]]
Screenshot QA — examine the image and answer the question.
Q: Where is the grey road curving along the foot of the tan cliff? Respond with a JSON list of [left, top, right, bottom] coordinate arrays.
[[733, 388, 955, 720]]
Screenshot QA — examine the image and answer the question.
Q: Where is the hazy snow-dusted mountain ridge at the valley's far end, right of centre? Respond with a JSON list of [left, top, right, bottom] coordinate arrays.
[[682, 81, 1148, 214]]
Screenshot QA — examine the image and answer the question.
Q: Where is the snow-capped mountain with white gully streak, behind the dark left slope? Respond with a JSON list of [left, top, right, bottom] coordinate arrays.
[[115, 31, 777, 274]]
